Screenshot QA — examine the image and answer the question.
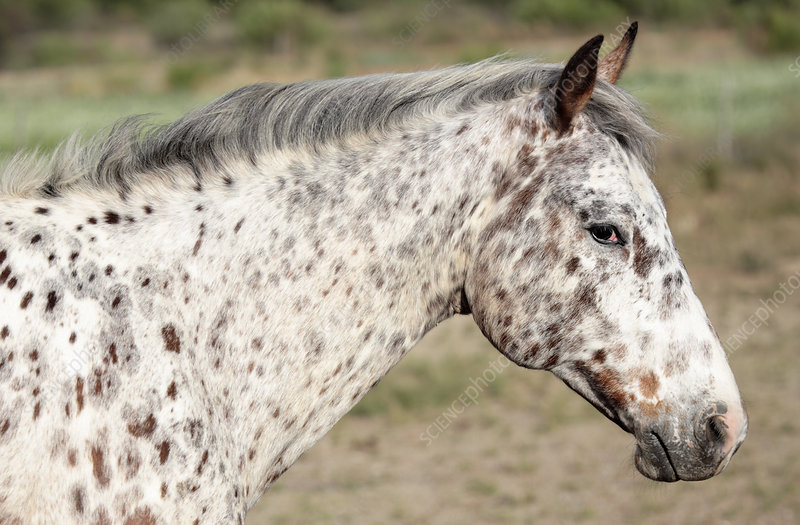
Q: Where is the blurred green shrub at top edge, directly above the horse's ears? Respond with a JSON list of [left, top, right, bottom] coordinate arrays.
[[511, 0, 625, 28]]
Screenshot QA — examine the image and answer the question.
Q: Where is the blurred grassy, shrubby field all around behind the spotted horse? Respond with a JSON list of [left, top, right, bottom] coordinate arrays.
[[0, 0, 800, 525]]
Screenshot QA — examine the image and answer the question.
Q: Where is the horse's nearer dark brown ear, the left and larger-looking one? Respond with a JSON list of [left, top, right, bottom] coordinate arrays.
[[553, 35, 603, 133]]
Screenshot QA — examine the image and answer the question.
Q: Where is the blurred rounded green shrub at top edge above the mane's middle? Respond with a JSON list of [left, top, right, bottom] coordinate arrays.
[[235, 0, 328, 51]]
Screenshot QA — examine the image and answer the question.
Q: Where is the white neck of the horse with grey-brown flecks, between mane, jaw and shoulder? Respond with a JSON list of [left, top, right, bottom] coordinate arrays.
[[0, 100, 520, 502]]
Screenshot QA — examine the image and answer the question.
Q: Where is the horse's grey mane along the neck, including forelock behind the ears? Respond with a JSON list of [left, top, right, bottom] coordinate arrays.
[[0, 59, 656, 196]]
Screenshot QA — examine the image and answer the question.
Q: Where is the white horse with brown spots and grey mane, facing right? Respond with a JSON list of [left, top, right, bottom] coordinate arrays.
[[0, 24, 747, 524]]
